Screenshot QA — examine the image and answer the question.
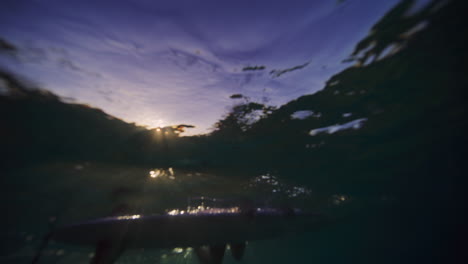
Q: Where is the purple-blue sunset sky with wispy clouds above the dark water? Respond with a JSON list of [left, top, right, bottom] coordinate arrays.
[[0, 0, 410, 135]]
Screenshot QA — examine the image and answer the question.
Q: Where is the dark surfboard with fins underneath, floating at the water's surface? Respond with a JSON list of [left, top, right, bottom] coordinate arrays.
[[47, 207, 324, 263]]
